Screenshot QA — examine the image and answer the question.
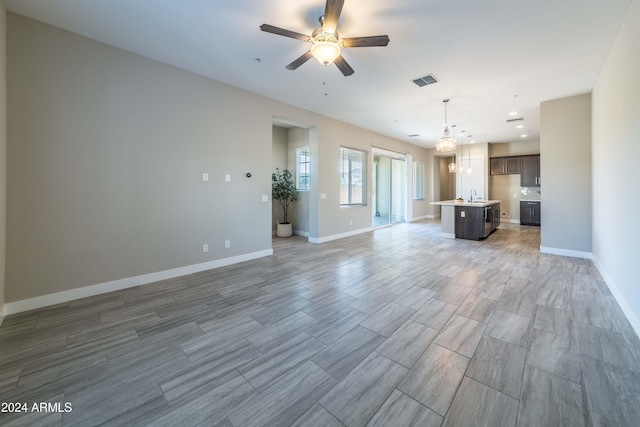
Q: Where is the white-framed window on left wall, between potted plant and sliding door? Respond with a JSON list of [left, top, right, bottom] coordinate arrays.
[[340, 147, 367, 206]]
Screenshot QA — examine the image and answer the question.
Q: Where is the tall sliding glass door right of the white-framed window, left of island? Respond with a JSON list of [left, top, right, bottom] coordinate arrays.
[[372, 148, 407, 227]]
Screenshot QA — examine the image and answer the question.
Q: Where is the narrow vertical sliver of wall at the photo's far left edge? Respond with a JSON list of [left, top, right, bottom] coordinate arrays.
[[0, 4, 7, 324]]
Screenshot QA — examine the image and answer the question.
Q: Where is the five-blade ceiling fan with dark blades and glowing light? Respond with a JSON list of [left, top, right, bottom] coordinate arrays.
[[260, 0, 389, 76]]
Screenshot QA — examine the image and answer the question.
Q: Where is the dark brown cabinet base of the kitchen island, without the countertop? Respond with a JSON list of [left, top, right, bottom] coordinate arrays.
[[455, 203, 500, 240]]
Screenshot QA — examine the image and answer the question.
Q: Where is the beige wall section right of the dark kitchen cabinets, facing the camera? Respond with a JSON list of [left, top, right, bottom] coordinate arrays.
[[540, 94, 591, 255]]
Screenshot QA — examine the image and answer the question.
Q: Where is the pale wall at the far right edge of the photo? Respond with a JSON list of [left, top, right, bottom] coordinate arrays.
[[592, 0, 640, 335]]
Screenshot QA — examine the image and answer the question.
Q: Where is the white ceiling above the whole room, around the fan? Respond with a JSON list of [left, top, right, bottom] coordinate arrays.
[[4, 0, 631, 147]]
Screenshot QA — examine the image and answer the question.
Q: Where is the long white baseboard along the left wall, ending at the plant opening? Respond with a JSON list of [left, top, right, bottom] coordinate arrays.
[[4, 249, 273, 315]]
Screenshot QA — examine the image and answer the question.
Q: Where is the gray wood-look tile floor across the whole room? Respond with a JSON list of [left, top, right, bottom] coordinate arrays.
[[0, 221, 640, 427]]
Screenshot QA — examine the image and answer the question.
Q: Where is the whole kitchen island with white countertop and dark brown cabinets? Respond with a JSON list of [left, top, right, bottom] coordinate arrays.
[[431, 200, 500, 240]]
